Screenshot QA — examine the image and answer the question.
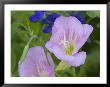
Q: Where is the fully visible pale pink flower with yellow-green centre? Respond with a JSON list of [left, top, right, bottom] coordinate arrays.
[[45, 16, 93, 67]]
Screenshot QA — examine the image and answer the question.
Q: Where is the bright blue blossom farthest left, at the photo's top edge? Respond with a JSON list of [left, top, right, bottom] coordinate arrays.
[[29, 11, 44, 22]]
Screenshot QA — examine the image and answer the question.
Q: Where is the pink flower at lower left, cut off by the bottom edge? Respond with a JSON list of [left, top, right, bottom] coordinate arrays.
[[19, 46, 55, 77]]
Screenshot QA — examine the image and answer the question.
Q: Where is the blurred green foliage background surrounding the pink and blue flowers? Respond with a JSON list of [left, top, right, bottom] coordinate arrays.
[[11, 11, 100, 77]]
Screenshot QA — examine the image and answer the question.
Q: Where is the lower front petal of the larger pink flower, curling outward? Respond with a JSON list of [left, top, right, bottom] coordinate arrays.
[[45, 45, 86, 67]]
